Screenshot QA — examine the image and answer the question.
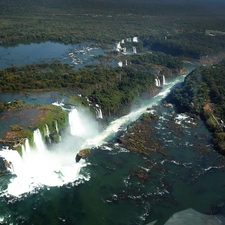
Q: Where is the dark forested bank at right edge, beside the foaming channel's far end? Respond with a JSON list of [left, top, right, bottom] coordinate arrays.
[[166, 60, 225, 154]]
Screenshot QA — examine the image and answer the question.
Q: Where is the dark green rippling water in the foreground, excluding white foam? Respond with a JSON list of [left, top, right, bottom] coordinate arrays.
[[0, 104, 225, 225]]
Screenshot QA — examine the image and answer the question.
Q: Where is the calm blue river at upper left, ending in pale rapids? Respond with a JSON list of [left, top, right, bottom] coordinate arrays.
[[0, 42, 106, 70]]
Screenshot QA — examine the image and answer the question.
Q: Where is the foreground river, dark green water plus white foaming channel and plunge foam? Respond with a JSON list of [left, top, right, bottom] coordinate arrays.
[[0, 62, 225, 225]]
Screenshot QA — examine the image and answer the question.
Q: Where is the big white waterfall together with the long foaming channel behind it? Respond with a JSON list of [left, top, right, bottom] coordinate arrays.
[[0, 70, 191, 196]]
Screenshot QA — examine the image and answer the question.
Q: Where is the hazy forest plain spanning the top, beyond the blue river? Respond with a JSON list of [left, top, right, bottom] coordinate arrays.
[[0, 0, 225, 59]]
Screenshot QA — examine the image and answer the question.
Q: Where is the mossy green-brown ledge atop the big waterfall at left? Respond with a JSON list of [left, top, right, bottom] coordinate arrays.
[[0, 105, 68, 152]]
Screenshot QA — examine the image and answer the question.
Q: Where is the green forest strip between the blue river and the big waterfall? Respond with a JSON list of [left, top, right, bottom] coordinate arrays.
[[0, 62, 155, 114]]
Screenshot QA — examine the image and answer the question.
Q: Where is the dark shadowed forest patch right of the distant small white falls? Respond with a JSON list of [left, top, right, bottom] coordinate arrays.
[[144, 31, 225, 59]]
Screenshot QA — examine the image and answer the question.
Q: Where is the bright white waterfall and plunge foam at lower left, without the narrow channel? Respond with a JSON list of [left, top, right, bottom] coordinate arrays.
[[0, 109, 95, 196]]
